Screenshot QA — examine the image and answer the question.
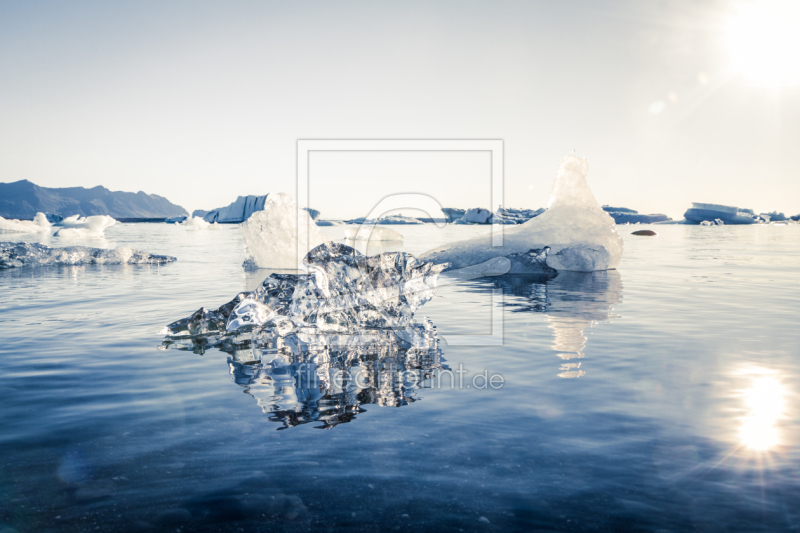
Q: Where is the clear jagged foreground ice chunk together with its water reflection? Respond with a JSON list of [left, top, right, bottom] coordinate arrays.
[[163, 243, 446, 428]]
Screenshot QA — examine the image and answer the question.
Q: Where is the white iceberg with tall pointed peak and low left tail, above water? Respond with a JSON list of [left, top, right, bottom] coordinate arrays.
[[420, 154, 622, 274]]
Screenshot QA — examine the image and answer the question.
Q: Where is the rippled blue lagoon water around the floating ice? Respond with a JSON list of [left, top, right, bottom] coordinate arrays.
[[0, 224, 800, 533]]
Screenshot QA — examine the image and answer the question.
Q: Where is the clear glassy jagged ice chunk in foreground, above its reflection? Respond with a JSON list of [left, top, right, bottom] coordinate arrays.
[[164, 242, 446, 340]]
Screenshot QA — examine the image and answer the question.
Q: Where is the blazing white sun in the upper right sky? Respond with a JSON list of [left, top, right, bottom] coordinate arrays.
[[725, 0, 800, 87]]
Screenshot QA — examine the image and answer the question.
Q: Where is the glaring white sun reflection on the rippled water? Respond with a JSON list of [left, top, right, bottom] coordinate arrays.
[[739, 368, 787, 452]]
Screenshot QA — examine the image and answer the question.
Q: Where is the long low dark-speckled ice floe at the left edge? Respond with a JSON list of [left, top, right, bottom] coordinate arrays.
[[0, 242, 175, 269]]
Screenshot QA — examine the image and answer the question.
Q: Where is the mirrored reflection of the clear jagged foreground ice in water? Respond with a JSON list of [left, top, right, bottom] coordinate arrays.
[[228, 322, 447, 429]]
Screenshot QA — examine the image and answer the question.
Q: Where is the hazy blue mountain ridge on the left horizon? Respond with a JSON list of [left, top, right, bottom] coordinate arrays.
[[0, 180, 188, 219]]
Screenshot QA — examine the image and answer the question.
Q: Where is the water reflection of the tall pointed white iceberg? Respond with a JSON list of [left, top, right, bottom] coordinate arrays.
[[478, 270, 622, 378]]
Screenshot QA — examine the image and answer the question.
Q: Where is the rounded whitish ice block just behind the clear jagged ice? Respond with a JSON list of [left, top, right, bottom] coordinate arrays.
[[238, 193, 329, 269]]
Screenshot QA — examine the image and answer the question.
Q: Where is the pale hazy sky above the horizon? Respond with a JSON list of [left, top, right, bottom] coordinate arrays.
[[0, 0, 800, 218]]
